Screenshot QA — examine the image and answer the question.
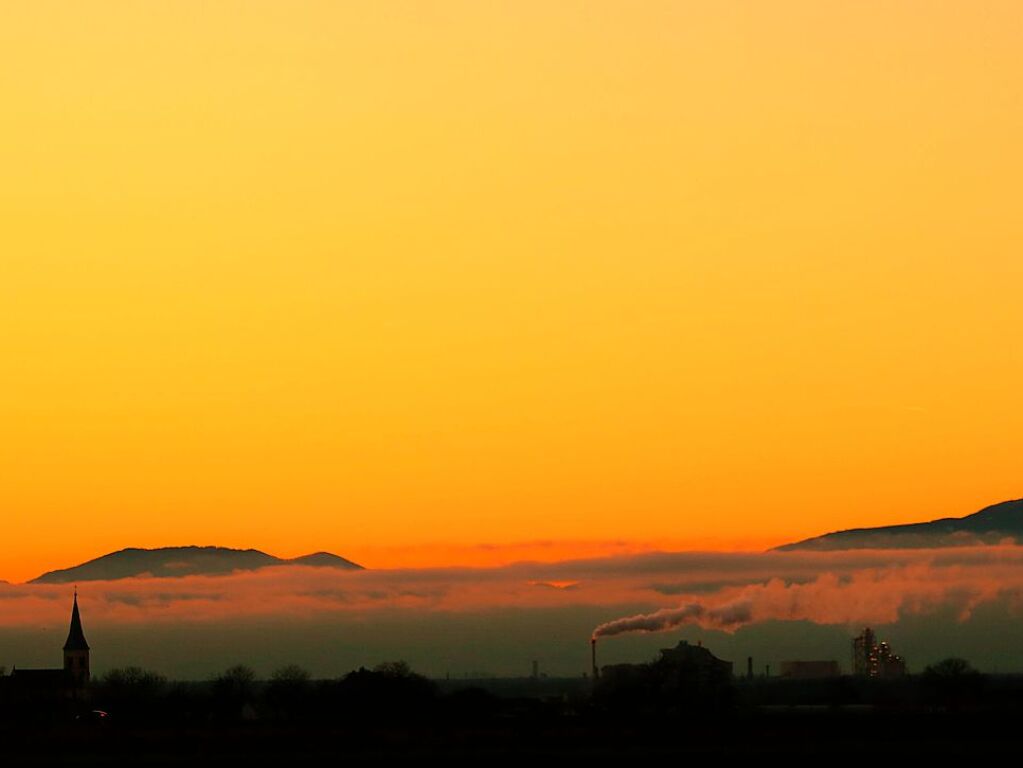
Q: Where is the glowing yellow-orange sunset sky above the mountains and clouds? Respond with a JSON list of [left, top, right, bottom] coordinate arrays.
[[0, 0, 1023, 578]]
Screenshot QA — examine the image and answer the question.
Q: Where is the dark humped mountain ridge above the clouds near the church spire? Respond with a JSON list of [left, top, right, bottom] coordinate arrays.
[[29, 546, 362, 584]]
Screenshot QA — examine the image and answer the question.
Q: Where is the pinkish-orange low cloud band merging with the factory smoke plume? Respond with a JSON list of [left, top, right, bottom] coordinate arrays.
[[6, 546, 1023, 637]]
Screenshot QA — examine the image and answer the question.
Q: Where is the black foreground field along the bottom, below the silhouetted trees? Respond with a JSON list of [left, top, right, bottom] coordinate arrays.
[[6, 712, 1020, 766]]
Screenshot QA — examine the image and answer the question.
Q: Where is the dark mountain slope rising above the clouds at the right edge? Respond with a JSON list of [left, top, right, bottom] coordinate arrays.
[[775, 499, 1023, 551]]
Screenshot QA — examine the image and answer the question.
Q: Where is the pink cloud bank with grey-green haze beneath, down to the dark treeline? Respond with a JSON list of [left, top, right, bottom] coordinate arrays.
[[6, 546, 1023, 678]]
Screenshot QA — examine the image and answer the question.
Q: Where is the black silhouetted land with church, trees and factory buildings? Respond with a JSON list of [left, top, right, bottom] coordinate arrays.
[[0, 594, 1023, 764]]
